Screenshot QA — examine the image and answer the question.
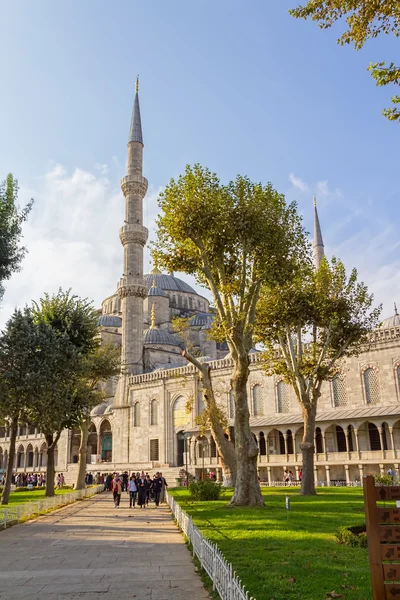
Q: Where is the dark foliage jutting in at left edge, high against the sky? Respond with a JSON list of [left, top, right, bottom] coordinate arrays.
[[0, 173, 33, 300]]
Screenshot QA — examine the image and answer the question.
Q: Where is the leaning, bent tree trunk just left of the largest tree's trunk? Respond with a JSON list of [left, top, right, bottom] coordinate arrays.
[[182, 350, 237, 487]]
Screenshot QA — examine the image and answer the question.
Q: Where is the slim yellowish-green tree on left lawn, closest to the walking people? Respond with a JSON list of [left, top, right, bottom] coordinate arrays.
[[75, 343, 121, 490]]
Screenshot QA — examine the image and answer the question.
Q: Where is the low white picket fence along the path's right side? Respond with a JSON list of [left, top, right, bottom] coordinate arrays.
[[167, 493, 255, 600]]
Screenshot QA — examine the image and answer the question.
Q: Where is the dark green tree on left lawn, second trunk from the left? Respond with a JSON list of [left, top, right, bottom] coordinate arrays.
[[33, 289, 100, 496]]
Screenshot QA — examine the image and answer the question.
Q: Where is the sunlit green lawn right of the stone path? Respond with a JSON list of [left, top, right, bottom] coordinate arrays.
[[171, 487, 371, 600]]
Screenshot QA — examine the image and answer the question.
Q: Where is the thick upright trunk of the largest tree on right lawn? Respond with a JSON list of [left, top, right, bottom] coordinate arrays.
[[230, 352, 264, 506]]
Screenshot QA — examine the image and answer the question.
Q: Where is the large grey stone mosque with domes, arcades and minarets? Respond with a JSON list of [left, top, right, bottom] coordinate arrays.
[[0, 85, 400, 485]]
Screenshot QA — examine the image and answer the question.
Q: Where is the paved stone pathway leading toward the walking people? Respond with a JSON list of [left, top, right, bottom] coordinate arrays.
[[0, 493, 209, 600]]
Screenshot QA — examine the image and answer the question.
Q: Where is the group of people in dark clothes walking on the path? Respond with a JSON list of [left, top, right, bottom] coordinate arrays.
[[108, 471, 168, 508]]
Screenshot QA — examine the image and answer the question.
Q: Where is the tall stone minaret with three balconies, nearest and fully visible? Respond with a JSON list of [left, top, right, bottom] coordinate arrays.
[[118, 78, 149, 375]]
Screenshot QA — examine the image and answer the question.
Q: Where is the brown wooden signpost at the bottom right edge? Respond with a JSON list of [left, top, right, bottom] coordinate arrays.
[[364, 475, 400, 600]]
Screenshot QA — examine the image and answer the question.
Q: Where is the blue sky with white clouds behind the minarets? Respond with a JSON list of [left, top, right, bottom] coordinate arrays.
[[0, 0, 400, 323]]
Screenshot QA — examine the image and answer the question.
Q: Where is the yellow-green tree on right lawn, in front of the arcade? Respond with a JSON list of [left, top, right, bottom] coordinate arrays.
[[256, 258, 381, 495]]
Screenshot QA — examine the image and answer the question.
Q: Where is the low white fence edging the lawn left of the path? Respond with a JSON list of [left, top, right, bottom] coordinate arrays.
[[0, 484, 104, 529]]
